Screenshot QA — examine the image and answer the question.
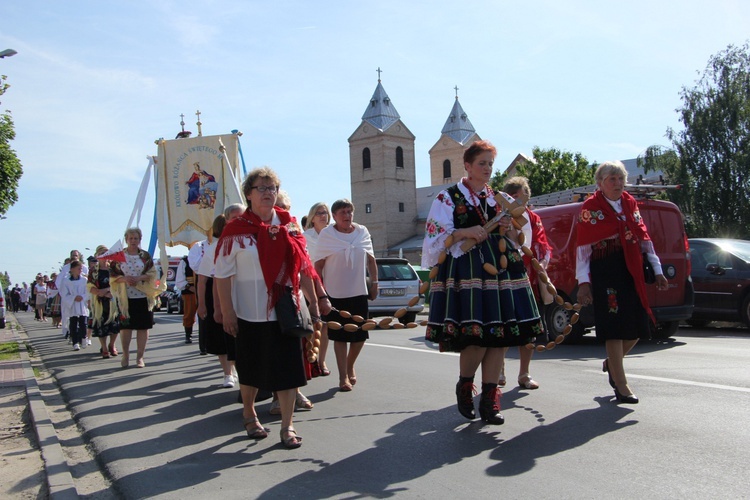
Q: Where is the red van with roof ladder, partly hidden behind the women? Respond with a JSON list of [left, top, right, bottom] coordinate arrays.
[[532, 193, 693, 339]]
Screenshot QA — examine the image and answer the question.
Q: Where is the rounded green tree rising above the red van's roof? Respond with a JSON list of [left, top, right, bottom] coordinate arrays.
[[490, 146, 595, 196]]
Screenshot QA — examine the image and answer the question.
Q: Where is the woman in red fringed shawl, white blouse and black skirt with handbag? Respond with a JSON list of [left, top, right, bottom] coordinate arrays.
[[214, 167, 330, 448]]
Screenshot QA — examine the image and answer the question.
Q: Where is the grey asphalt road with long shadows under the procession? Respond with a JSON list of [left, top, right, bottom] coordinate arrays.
[[19, 313, 750, 499]]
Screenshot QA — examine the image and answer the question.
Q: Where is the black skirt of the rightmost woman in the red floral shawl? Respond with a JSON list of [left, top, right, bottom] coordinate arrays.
[[591, 248, 649, 340]]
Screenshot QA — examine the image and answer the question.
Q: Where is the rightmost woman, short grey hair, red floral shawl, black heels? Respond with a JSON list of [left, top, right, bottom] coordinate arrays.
[[576, 161, 669, 404]]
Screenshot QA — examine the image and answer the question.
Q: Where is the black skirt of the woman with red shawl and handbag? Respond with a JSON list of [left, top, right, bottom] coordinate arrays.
[[235, 318, 307, 391]]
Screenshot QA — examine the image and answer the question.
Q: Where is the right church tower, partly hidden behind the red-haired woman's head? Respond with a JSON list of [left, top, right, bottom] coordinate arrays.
[[429, 87, 481, 186]]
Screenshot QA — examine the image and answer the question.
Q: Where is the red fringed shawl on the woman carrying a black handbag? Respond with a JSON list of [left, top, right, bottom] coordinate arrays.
[[215, 207, 317, 311]]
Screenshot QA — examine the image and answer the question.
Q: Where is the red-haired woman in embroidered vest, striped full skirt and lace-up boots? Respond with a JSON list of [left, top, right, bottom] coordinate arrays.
[[422, 141, 542, 425]]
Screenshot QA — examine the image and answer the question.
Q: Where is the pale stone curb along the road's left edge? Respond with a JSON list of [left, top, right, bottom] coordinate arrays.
[[12, 316, 79, 500]]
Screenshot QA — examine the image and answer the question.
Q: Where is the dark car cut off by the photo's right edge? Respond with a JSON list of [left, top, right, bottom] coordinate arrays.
[[688, 238, 750, 326]]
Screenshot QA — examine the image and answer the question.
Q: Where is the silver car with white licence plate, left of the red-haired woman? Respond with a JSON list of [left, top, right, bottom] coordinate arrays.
[[368, 258, 424, 324]]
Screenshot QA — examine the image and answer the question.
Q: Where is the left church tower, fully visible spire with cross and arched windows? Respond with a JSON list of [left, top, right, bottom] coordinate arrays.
[[349, 74, 420, 257]]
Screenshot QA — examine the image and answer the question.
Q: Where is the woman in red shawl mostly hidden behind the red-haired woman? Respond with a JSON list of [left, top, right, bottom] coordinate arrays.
[[499, 177, 554, 390]]
